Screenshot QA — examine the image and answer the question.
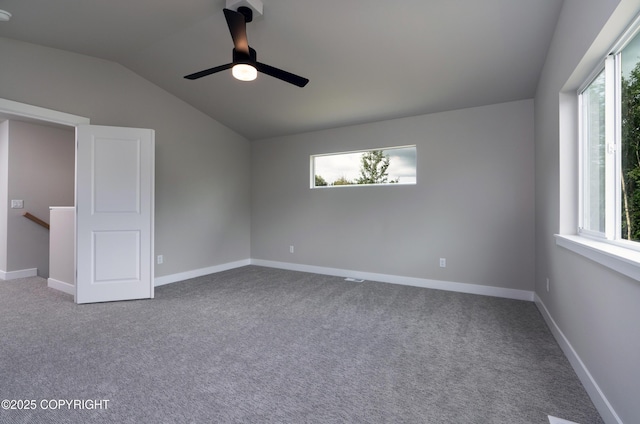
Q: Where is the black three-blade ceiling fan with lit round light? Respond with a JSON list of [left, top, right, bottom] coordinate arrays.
[[185, 6, 309, 87]]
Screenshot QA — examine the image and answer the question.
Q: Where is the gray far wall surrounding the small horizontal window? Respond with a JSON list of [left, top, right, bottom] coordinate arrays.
[[251, 100, 534, 291]]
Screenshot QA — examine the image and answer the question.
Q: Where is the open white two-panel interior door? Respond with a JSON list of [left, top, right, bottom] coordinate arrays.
[[75, 125, 155, 303]]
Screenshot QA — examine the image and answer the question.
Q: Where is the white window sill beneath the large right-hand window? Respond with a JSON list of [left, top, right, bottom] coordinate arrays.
[[555, 234, 640, 281]]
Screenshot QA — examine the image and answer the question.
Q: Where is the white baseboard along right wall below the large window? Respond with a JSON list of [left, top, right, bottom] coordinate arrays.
[[535, 294, 623, 424]]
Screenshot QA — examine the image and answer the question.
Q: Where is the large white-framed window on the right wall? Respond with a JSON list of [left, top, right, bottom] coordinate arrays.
[[579, 23, 640, 248]]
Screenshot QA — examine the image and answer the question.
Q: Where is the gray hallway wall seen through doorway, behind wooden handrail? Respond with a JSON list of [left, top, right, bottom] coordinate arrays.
[[3, 121, 75, 278]]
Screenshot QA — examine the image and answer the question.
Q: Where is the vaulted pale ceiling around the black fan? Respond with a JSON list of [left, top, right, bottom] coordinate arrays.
[[0, 0, 562, 140]]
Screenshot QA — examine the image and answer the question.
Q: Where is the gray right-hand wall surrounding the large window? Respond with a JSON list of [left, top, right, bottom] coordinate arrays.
[[535, 0, 640, 423]]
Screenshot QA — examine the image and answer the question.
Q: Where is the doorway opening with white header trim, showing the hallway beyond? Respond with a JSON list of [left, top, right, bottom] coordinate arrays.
[[0, 99, 90, 294]]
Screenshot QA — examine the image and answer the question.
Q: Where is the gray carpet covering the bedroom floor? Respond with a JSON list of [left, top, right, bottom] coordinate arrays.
[[0, 266, 602, 424]]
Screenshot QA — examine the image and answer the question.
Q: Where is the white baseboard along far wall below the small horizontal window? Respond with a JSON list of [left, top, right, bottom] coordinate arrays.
[[251, 259, 534, 302]]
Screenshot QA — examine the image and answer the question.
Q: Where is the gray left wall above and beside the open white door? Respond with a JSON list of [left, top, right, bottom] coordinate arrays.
[[0, 38, 250, 277]]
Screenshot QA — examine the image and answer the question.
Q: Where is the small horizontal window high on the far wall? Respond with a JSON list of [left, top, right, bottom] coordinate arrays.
[[311, 146, 416, 188]]
